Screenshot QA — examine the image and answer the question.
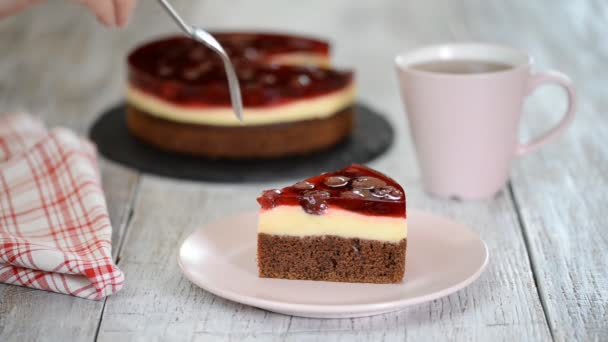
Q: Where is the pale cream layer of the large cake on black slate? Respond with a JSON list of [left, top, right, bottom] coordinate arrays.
[[127, 82, 356, 126]]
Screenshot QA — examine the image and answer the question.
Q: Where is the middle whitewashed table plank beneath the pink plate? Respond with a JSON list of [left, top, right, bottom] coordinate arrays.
[[98, 0, 550, 341]]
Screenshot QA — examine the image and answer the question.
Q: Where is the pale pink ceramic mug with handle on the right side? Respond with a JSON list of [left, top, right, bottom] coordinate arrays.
[[395, 43, 576, 199]]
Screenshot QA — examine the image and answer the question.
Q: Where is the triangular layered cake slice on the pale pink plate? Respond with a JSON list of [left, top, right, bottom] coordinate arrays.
[[257, 164, 407, 283]]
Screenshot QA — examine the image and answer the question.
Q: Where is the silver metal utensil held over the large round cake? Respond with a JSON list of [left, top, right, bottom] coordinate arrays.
[[158, 0, 243, 121]]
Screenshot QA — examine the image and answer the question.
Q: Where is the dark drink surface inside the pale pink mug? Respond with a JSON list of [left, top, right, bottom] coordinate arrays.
[[412, 59, 513, 74]]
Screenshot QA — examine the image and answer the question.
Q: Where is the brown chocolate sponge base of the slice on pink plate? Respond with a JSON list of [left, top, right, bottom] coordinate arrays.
[[258, 234, 406, 284]]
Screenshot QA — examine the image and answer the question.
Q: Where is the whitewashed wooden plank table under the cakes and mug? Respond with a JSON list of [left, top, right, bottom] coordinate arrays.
[[0, 0, 608, 342]]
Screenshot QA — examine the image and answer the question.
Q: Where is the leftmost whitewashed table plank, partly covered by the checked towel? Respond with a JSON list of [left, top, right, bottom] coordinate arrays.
[[0, 3, 139, 341]]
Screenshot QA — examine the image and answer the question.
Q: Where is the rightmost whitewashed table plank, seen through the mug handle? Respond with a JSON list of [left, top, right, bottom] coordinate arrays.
[[512, 2, 608, 341]]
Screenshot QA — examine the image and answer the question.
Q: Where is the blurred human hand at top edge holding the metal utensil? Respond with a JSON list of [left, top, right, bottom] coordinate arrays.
[[0, 0, 137, 26]]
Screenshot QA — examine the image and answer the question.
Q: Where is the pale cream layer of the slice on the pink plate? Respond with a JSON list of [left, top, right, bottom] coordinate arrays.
[[258, 205, 407, 242]]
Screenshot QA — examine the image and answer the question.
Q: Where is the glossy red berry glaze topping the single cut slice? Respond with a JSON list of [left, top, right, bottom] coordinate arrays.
[[257, 164, 406, 217]]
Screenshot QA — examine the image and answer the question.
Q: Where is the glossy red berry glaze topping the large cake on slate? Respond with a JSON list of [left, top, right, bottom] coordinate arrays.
[[128, 33, 353, 107]]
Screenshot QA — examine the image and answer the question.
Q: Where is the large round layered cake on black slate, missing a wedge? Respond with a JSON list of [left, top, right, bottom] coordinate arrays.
[[127, 33, 355, 159]]
